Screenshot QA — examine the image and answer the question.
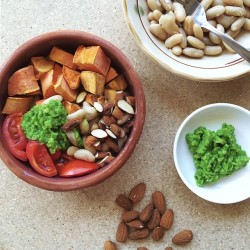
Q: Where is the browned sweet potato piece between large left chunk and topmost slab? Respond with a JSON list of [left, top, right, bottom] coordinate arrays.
[[31, 56, 55, 79]]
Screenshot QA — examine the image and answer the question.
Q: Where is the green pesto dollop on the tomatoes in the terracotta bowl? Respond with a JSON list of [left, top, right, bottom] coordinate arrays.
[[21, 100, 69, 154]]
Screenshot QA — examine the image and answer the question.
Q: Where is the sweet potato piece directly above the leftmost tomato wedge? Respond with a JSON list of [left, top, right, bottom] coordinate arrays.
[[2, 96, 34, 114]]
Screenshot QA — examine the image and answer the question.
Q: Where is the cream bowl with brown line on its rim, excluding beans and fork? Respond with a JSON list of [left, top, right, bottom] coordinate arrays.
[[123, 0, 250, 82]]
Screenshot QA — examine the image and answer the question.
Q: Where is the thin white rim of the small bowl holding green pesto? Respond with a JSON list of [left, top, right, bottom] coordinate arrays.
[[173, 102, 250, 204]]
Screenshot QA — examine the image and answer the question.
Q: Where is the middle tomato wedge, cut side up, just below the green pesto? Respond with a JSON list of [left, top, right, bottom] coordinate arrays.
[[26, 141, 57, 177]]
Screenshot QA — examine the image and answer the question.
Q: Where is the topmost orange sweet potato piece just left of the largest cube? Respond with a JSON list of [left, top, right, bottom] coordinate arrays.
[[49, 47, 76, 69]]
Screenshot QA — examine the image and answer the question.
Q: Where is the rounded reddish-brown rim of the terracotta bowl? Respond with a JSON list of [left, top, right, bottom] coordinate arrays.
[[0, 30, 146, 191]]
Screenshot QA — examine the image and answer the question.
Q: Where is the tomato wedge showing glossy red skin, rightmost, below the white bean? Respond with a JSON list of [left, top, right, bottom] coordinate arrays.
[[58, 159, 99, 177]]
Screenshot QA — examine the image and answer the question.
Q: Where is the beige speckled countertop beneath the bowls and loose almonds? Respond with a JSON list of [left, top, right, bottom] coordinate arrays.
[[0, 0, 250, 250]]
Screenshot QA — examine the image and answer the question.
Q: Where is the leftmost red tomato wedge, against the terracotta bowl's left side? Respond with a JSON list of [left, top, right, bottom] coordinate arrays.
[[2, 113, 27, 161]]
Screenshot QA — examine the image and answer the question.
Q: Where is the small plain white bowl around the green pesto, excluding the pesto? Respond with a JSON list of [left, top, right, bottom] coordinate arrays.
[[173, 103, 250, 204]]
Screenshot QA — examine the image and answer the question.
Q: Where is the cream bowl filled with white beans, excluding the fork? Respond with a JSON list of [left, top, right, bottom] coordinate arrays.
[[123, 0, 250, 82]]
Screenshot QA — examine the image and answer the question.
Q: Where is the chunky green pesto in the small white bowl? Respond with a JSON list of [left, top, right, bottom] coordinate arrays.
[[186, 123, 250, 187]]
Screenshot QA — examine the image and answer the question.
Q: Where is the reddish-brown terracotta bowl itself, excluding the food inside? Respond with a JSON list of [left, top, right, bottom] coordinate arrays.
[[0, 30, 146, 191]]
